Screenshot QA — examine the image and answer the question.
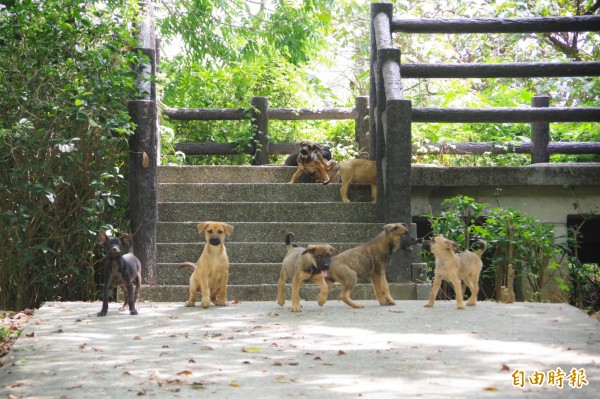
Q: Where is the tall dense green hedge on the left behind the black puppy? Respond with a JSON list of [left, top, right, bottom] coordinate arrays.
[[0, 0, 139, 309]]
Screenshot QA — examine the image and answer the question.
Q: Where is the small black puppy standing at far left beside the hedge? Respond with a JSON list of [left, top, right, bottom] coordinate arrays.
[[98, 230, 142, 316]]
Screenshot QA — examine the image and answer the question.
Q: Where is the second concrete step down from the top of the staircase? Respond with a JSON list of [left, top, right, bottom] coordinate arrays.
[[158, 183, 371, 202]]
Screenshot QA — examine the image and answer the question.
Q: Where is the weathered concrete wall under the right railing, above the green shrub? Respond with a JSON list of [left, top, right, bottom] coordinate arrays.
[[412, 164, 600, 239]]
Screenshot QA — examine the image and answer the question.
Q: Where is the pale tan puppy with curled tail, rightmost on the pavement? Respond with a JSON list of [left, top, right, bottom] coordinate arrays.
[[423, 236, 487, 309]]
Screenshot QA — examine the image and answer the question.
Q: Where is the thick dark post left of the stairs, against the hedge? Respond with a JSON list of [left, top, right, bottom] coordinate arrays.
[[129, 100, 158, 284]]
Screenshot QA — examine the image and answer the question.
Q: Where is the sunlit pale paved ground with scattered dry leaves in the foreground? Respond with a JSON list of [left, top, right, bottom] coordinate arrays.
[[0, 301, 600, 399]]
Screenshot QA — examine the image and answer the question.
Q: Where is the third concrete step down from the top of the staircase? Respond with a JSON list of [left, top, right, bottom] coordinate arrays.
[[158, 202, 378, 223]]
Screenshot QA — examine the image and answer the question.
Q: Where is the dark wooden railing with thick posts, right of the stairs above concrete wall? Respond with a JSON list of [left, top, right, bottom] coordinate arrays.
[[369, 3, 600, 225]]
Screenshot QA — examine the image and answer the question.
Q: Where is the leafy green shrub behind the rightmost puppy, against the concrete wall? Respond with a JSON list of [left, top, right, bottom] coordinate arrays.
[[424, 195, 563, 301]]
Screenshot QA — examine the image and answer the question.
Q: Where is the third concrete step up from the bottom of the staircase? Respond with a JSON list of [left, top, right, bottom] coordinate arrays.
[[156, 241, 355, 263]]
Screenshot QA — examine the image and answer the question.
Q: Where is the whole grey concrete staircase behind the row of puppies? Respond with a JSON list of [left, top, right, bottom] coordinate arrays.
[[141, 166, 424, 302]]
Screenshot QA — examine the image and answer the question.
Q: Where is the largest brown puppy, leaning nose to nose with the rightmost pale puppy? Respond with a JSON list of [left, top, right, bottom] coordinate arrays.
[[327, 223, 417, 308]]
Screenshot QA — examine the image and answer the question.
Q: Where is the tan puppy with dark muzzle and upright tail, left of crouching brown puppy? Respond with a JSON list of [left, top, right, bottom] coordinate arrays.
[[277, 233, 335, 312]]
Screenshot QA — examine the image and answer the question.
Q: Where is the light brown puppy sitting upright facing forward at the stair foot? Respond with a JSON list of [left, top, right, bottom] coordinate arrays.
[[179, 222, 233, 309]]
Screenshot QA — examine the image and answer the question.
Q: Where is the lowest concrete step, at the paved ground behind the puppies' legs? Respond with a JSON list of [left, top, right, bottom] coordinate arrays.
[[141, 283, 431, 304]]
